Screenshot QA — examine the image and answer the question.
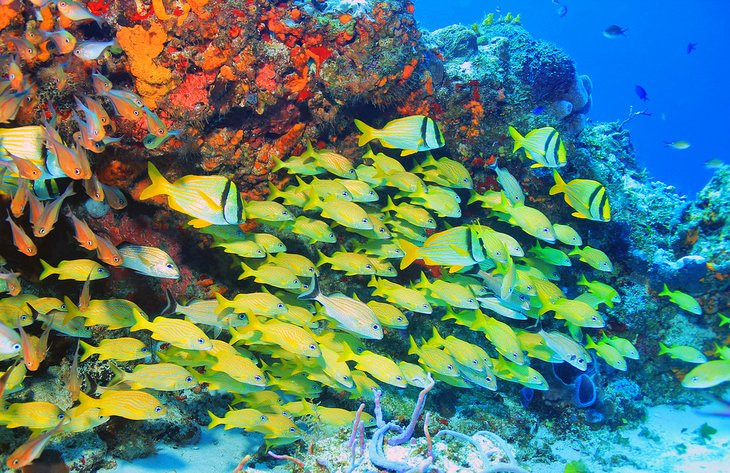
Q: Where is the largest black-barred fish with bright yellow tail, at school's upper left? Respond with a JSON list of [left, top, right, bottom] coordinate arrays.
[[139, 162, 246, 228]]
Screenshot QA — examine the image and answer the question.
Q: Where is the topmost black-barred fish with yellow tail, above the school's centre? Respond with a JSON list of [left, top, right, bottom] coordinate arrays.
[[355, 115, 444, 156]]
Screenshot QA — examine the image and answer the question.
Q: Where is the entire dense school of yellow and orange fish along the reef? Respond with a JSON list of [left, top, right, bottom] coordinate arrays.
[[0, 12, 727, 460]]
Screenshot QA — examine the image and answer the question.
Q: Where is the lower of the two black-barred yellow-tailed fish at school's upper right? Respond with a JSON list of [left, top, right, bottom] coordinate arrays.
[[550, 169, 611, 222]]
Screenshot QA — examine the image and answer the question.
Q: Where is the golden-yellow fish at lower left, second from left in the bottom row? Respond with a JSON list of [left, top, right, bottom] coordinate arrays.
[[77, 389, 167, 420]]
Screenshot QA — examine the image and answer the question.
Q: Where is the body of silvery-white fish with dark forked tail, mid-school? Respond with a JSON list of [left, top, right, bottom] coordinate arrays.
[[315, 294, 383, 340]]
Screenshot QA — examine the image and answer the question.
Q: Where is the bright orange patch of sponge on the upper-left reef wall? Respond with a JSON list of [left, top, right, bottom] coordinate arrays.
[[117, 23, 174, 109]]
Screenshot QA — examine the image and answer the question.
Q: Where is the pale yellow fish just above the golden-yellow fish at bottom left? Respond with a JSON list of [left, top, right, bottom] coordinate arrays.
[[109, 363, 197, 391]]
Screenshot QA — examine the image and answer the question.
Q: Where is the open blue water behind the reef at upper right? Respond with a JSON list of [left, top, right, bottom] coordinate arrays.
[[416, 0, 730, 197]]
